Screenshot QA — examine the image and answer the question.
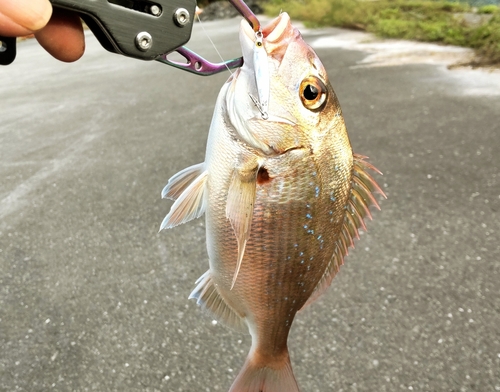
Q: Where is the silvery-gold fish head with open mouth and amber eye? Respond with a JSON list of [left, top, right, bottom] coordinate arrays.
[[226, 12, 347, 156]]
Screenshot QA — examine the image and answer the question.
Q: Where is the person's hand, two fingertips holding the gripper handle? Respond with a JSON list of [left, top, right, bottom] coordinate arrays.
[[0, 0, 85, 62]]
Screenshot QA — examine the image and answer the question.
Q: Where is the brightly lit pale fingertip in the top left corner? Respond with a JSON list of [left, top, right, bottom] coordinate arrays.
[[1, 0, 52, 35]]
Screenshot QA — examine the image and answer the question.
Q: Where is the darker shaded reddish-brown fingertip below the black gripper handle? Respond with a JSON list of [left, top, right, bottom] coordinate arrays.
[[35, 8, 85, 62]]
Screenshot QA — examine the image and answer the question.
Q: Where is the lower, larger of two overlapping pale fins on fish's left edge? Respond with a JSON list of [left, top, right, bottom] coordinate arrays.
[[160, 171, 208, 231]]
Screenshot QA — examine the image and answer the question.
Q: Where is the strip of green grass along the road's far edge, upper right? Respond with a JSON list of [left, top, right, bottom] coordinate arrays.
[[265, 0, 500, 66]]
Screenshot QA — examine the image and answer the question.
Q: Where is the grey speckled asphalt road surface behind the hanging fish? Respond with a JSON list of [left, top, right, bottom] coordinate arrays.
[[0, 16, 500, 392]]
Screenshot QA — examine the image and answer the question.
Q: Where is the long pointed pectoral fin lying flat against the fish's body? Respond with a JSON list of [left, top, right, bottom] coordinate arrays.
[[226, 167, 258, 289]]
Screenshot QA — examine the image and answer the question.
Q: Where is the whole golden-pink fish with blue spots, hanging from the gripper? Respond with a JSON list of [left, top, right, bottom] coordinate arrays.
[[160, 12, 385, 392]]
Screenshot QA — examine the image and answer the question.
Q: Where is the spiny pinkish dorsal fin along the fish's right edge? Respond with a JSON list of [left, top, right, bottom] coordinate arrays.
[[301, 154, 386, 310]]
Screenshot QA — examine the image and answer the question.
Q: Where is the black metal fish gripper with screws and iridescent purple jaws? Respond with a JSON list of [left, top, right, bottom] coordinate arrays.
[[0, 0, 260, 75]]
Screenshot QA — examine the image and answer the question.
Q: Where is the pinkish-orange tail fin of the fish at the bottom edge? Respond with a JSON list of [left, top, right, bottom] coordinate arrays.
[[229, 352, 300, 392]]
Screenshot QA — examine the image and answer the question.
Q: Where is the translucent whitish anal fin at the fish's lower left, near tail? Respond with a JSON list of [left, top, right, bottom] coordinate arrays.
[[189, 270, 248, 332]]
